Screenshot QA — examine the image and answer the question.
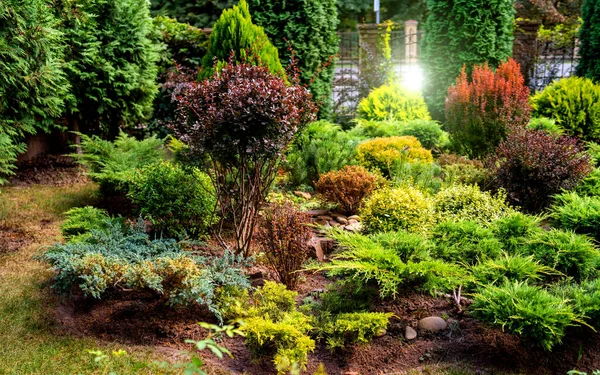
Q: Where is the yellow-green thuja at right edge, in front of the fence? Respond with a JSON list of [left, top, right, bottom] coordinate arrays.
[[531, 77, 600, 141]]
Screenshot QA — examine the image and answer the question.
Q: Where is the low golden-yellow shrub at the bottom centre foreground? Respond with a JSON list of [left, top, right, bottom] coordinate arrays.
[[241, 281, 315, 374]]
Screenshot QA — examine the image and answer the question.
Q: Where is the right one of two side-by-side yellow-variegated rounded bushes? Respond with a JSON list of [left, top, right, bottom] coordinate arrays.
[[433, 185, 514, 225]]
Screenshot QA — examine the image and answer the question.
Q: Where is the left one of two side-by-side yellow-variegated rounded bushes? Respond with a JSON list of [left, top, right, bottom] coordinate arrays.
[[360, 187, 433, 233]]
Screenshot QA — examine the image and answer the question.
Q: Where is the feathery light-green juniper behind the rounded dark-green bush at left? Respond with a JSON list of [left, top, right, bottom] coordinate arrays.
[[73, 133, 166, 194]]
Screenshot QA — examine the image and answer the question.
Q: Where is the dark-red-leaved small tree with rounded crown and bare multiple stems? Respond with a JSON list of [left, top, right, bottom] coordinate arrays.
[[174, 63, 316, 255]]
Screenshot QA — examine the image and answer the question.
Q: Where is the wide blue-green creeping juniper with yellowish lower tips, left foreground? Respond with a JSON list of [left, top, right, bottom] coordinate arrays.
[[41, 222, 250, 318]]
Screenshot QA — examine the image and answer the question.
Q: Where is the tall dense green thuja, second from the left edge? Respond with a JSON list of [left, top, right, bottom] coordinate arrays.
[[56, 0, 161, 139]]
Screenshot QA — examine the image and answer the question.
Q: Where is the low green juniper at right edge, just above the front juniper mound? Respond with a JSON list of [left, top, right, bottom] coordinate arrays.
[[525, 229, 600, 280]]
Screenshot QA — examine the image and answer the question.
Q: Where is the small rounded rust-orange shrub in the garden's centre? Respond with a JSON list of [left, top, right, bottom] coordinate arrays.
[[316, 166, 383, 213]]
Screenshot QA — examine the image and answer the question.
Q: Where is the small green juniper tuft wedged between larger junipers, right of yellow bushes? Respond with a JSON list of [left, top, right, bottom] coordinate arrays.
[[490, 212, 543, 254]]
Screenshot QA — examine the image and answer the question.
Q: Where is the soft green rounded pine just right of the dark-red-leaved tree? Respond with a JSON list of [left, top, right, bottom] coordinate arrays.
[[285, 121, 359, 186]]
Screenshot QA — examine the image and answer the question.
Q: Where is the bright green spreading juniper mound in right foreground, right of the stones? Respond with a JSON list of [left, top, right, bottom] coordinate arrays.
[[471, 281, 578, 350]]
